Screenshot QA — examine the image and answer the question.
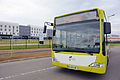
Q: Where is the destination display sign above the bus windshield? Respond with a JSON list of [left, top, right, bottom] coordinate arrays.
[[55, 10, 99, 25]]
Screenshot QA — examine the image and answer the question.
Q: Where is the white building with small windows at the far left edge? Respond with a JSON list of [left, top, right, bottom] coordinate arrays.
[[0, 22, 19, 36]]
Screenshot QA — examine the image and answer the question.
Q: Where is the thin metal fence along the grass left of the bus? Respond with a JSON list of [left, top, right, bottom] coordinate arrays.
[[0, 38, 51, 50]]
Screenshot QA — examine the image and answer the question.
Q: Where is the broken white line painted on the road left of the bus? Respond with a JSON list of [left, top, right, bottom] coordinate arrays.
[[0, 66, 56, 80]]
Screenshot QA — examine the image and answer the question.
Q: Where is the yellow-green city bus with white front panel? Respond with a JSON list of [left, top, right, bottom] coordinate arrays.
[[52, 8, 111, 74]]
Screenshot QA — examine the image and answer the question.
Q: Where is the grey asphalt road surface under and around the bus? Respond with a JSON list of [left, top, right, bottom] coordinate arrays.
[[0, 46, 120, 80]]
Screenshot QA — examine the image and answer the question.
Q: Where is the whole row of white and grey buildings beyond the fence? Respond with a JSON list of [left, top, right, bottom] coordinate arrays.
[[0, 21, 52, 39]]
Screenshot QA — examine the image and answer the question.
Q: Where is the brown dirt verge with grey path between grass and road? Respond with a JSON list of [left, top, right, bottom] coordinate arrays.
[[0, 48, 51, 62]]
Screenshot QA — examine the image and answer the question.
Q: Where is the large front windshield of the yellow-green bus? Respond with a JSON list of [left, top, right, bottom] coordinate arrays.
[[53, 20, 100, 53]]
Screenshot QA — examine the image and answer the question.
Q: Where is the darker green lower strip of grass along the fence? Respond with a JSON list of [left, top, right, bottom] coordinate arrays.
[[0, 45, 51, 50]]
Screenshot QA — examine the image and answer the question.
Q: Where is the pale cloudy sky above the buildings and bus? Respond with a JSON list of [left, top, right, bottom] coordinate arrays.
[[0, 0, 120, 34]]
